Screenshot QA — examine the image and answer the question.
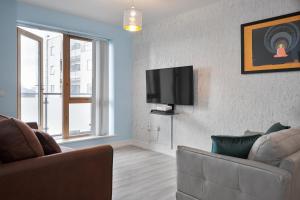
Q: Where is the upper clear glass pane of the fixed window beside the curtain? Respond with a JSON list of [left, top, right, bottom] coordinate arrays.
[[70, 39, 93, 97]]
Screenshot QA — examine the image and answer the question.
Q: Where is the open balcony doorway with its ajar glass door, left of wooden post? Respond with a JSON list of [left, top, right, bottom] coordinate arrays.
[[18, 27, 63, 137]]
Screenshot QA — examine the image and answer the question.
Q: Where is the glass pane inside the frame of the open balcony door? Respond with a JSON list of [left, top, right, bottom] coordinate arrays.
[[20, 35, 39, 122]]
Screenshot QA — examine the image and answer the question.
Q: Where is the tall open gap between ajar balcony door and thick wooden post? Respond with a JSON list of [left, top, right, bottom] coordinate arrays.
[[43, 31, 63, 136]]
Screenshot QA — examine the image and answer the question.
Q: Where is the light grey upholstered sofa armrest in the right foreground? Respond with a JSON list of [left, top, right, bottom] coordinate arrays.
[[177, 146, 291, 200]]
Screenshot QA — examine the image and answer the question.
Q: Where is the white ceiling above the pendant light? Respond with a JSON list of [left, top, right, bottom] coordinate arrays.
[[18, 0, 218, 25]]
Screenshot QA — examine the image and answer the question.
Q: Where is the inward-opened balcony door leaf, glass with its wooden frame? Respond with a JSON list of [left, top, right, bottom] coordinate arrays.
[[18, 28, 43, 127]]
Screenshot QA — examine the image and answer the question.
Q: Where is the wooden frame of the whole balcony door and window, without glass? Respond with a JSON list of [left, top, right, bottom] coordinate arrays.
[[16, 24, 98, 139]]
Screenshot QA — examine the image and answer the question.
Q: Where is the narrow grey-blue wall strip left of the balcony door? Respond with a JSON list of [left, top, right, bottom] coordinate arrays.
[[0, 0, 17, 116]]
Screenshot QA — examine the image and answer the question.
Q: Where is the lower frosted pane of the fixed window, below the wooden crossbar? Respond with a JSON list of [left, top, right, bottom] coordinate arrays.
[[69, 103, 92, 136]]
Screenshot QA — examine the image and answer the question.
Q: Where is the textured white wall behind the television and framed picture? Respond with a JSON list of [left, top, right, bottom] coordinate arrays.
[[133, 0, 300, 155]]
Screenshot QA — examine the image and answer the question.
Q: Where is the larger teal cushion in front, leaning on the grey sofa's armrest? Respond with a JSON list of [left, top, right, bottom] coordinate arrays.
[[211, 135, 261, 159]]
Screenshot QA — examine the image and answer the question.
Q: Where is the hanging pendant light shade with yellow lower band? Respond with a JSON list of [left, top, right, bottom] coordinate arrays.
[[123, 6, 143, 32]]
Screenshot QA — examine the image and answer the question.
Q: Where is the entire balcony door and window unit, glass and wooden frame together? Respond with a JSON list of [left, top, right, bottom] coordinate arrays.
[[17, 26, 96, 138]]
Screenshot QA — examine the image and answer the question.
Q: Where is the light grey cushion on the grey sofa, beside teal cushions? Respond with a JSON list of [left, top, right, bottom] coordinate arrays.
[[248, 128, 300, 166]]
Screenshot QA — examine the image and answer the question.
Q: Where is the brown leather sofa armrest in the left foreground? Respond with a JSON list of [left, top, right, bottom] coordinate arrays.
[[0, 146, 113, 200]]
